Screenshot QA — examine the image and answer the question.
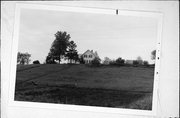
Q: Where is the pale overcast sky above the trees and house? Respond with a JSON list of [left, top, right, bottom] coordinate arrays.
[[18, 9, 157, 63]]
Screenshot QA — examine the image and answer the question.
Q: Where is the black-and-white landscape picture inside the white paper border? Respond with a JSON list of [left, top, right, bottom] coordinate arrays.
[[14, 9, 158, 110]]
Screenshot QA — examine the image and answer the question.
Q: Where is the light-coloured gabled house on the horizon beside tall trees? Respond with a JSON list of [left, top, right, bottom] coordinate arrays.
[[81, 50, 99, 64]]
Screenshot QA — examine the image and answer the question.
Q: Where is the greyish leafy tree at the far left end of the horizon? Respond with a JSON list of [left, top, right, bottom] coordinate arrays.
[[17, 52, 31, 65]]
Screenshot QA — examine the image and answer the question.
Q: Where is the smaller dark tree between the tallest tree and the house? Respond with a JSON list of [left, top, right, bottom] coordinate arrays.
[[65, 41, 78, 63]]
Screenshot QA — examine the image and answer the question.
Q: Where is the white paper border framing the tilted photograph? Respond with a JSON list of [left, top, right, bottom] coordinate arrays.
[[8, 3, 163, 116]]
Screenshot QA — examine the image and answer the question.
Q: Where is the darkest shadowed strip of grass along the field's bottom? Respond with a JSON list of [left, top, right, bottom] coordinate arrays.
[[15, 85, 152, 110]]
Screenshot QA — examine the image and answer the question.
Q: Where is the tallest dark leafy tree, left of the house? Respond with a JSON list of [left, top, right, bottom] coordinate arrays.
[[48, 31, 71, 63]]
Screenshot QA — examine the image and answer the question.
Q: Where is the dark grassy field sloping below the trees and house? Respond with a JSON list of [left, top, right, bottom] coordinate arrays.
[[15, 64, 154, 110]]
